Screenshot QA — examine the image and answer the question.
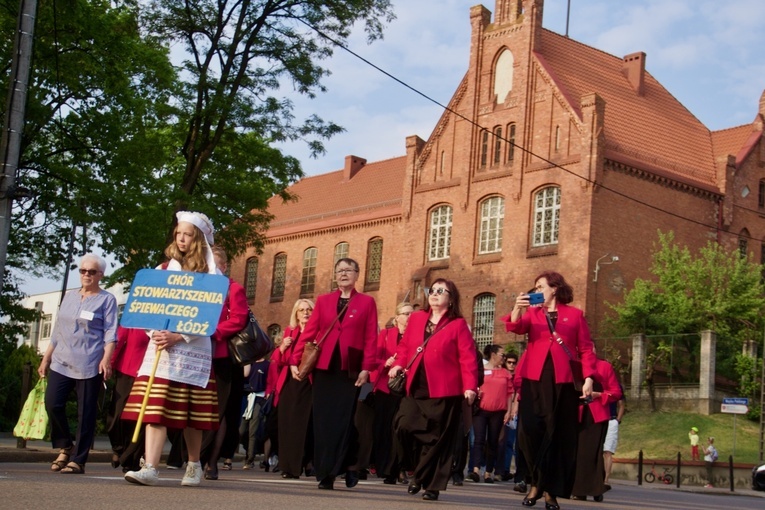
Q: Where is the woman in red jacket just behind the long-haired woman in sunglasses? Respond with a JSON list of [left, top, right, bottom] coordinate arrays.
[[372, 302, 414, 485]]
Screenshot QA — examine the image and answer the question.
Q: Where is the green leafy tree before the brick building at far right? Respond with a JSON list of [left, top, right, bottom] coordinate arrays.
[[608, 232, 765, 377]]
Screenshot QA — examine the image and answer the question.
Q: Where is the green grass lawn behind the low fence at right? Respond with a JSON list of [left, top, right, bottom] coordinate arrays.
[[615, 411, 760, 464]]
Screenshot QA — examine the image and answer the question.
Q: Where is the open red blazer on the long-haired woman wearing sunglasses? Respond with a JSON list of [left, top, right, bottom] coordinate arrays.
[[395, 311, 478, 398]]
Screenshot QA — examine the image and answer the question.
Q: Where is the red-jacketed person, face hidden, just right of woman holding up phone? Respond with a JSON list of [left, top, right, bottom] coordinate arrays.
[[571, 359, 622, 501]]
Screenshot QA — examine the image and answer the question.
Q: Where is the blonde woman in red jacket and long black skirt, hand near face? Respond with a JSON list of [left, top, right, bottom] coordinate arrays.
[[271, 299, 313, 478]]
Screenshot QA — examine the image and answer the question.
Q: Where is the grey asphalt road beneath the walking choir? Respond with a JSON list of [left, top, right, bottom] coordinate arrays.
[[0, 462, 765, 510]]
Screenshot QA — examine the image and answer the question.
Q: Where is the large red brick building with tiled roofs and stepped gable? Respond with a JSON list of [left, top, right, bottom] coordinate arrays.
[[231, 0, 765, 343]]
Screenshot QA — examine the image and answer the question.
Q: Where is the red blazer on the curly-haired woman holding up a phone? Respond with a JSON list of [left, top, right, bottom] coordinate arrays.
[[501, 305, 596, 383]]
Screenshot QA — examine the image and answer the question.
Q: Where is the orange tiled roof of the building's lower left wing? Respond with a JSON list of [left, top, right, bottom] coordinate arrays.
[[267, 156, 406, 237]]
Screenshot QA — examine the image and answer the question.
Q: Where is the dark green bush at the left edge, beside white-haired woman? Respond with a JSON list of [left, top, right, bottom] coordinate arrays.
[[0, 342, 40, 432]]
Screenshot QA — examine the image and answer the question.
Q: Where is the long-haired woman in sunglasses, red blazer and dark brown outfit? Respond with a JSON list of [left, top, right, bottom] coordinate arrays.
[[388, 278, 478, 501]]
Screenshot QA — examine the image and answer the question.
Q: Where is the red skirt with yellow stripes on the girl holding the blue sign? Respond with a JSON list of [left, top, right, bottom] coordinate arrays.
[[121, 375, 219, 430]]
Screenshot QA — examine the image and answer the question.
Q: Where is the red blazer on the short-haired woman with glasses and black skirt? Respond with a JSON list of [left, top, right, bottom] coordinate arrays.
[[290, 289, 377, 373]]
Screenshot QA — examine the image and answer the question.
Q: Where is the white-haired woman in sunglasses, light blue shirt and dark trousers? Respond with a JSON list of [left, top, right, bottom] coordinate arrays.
[[37, 254, 117, 474]]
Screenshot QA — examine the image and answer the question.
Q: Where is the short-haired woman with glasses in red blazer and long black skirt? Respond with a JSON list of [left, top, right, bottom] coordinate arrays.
[[290, 258, 377, 490]]
